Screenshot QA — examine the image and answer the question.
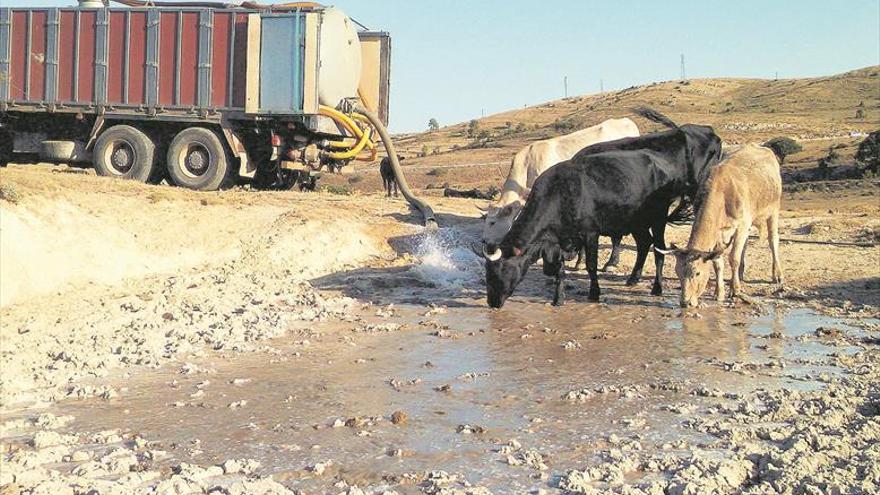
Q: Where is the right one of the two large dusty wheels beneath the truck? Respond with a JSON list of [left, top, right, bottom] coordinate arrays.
[[167, 127, 230, 191]]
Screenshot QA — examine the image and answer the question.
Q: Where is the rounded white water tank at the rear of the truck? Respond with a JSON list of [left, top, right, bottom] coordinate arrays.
[[318, 7, 362, 107]]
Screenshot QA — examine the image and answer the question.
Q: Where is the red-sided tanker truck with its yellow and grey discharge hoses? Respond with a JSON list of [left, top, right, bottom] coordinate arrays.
[[0, 0, 433, 227]]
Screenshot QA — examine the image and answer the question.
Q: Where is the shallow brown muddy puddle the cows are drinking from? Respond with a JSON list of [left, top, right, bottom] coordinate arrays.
[[5, 231, 872, 493]]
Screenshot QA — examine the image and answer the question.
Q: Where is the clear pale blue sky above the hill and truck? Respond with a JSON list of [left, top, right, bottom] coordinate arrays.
[[13, 0, 880, 132]]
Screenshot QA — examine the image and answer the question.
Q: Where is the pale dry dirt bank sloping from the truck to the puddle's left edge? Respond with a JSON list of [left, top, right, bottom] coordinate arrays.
[[0, 170, 416, 405]]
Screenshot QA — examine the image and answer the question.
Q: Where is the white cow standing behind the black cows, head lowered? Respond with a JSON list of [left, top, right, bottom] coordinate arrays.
[[483, 118, 639, 267]]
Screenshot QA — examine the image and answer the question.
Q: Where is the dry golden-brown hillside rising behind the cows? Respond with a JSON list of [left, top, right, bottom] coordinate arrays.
[[331, 66, 880, 196]]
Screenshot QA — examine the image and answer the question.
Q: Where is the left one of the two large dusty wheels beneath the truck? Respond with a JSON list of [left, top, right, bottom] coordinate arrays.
[[94, 125, 161, 182]]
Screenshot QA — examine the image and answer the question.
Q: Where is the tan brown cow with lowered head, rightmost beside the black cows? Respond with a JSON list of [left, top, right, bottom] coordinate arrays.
[[655, 144, 782, 307]]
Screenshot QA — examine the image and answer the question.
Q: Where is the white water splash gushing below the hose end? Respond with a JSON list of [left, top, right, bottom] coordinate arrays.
[[410, 228, 483, 289]]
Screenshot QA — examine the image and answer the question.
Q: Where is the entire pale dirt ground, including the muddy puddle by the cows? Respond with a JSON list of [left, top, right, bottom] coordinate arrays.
[[0, 166, 880, 495]]
